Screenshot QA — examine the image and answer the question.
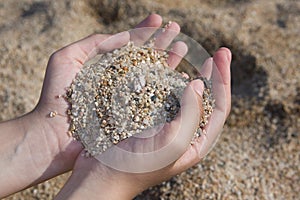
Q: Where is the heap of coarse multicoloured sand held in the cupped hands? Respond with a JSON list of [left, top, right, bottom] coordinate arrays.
[[66, 42, 214, 156]]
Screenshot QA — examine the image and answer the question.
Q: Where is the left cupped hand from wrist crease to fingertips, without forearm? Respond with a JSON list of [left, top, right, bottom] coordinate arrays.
[[32, 15, 161, 181]]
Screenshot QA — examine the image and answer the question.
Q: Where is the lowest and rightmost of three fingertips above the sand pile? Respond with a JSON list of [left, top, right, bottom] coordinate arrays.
[[167, 41, 188, 69]]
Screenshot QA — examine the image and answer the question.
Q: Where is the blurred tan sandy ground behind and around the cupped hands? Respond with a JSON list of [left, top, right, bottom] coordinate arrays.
[[0, 0, 300, 199]]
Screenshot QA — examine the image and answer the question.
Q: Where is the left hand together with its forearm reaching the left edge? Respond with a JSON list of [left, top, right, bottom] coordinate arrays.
[[0, 15, 168, 198]]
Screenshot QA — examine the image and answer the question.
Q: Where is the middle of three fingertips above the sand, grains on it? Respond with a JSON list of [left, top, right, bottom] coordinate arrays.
[[154, 22, 180, 50]]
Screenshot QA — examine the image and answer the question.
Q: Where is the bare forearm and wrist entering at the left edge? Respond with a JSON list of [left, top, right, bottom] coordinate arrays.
[[0, 112, 51, 196]]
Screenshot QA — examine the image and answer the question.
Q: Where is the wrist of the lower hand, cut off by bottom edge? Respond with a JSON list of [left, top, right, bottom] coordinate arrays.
[[57, 157, 140, 199]]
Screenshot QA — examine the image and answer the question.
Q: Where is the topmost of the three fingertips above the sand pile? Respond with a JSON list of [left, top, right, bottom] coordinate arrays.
[[130, 14, 162, 46]]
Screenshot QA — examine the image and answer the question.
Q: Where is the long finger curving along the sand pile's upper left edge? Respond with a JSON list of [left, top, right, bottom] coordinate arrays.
[[54, 32, 129, 67]]
